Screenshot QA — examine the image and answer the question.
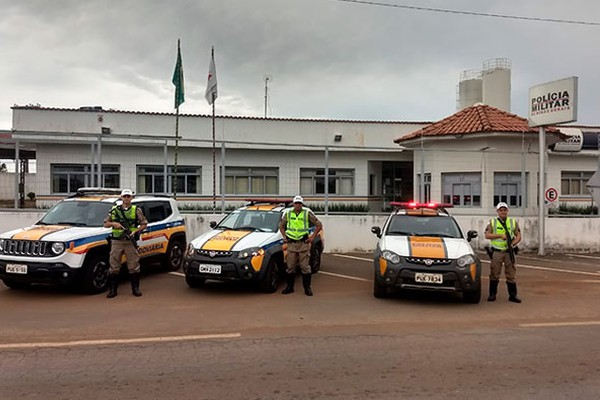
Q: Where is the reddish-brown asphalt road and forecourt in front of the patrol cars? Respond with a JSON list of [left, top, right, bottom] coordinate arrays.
[[0, 254, 600, 400]]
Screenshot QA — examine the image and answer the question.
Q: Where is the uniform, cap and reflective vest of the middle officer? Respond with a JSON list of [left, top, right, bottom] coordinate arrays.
[[279, 196, 322, 296]]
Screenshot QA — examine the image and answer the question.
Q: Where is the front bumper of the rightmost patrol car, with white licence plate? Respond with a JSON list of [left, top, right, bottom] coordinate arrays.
[[375, 263, 481, 292]]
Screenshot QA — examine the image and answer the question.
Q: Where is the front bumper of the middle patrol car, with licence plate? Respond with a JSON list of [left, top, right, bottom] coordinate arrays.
[[183, 257, 264, 281]]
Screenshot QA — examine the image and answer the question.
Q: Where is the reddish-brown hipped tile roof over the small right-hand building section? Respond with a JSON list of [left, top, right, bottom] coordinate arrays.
[[394, 104, 560, 143]]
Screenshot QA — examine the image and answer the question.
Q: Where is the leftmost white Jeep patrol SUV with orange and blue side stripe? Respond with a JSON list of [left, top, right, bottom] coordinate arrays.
[[0, 188, 186, 293]]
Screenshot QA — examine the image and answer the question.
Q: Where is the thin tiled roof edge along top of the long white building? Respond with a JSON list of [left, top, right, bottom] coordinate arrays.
[[11, 105, 432, 125]]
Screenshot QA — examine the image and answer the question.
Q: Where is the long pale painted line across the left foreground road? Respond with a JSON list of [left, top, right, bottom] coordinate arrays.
[[0, 333, 242, 350]]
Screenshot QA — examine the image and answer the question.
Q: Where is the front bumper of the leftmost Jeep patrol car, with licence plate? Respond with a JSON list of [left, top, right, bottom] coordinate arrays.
[[0, 261, 81, 285]]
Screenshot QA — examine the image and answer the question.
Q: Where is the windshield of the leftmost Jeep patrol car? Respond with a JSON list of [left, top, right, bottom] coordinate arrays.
[[38, 201, 113, 227]]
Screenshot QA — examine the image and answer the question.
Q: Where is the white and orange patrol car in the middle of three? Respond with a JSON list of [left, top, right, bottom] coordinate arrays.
[[183, 199, 323, 293]]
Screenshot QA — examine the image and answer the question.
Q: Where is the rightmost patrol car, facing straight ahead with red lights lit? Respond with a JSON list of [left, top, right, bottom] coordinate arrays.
[[371, 202, 481, 303]]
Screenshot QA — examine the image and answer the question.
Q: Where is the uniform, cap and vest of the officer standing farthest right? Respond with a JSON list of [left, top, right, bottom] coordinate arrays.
[[485, 203, 521, 303]]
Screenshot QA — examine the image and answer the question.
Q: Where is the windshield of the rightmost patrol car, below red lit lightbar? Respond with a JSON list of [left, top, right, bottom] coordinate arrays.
[[386, 215, 462, 238]]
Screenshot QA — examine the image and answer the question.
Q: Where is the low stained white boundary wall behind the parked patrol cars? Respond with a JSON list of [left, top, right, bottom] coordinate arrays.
[[0, 210, 600, 252]]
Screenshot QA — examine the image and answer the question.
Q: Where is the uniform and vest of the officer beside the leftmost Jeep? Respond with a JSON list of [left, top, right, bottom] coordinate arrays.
[[104, 192, 148, 297]]
